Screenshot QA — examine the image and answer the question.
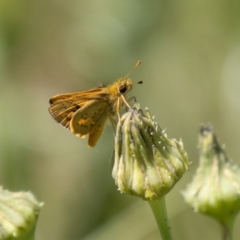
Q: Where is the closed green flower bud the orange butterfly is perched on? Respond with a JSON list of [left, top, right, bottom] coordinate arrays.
[[112, 104, 189, 200]]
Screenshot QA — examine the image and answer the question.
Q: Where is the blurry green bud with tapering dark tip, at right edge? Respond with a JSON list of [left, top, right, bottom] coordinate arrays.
[[183, 125, 240, 221]]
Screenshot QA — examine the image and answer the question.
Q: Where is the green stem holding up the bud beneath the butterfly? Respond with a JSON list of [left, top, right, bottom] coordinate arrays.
[[148, 197, 173, 240]]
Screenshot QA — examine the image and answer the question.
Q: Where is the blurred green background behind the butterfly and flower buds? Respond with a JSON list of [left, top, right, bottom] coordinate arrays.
[[0, 0, 240, 240]]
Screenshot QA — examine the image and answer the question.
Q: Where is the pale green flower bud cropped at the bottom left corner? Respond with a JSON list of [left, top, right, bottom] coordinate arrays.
[[0, 187, 42, 240]]
